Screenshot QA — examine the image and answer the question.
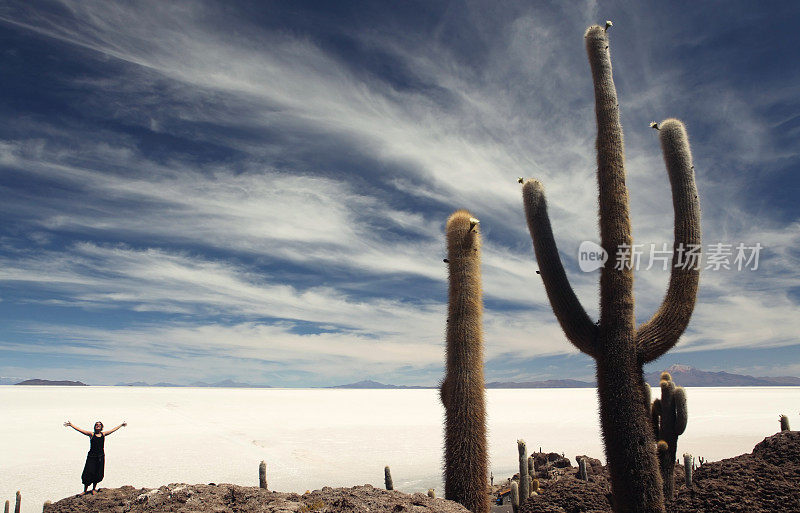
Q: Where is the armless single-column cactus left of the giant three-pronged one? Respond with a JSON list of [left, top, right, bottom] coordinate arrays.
[[441, 210, 489, 513]]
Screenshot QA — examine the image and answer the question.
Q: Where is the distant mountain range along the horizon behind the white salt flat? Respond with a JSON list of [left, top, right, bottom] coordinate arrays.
[[6, 365, 800, 390]]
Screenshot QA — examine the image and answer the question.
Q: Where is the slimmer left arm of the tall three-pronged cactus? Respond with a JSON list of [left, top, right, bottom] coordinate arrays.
[[522, 180, 597, 357]]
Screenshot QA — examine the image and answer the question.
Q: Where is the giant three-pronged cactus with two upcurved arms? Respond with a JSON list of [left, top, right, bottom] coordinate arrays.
[[523, 24, 700, 513]]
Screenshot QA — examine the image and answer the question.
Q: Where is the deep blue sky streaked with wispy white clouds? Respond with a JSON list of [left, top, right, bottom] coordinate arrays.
[[0, 0, 800, 387]]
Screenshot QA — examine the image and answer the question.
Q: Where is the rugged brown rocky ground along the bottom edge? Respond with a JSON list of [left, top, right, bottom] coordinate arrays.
[[44, 431, 800, 513]]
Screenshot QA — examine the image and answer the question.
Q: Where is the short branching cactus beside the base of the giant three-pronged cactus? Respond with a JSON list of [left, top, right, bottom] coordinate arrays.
[[651, 372, 689, 499]]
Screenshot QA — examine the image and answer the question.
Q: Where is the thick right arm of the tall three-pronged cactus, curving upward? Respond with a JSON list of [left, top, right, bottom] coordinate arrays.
[[636, 119, 701, 363]]
